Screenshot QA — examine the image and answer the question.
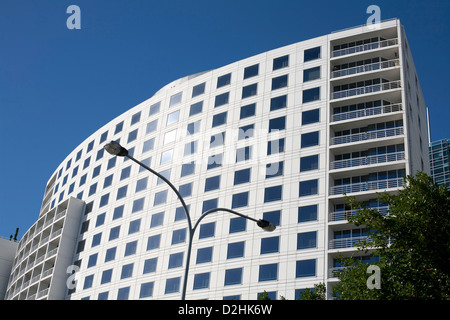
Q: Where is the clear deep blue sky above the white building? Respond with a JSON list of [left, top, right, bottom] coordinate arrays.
[[0, 0, 450, 237]]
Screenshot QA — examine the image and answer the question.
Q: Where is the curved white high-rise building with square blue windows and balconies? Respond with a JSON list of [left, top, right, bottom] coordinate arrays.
[[6, 19, 429, 300]]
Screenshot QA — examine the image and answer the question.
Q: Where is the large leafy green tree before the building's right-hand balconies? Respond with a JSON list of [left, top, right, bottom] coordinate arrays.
[[333, 172, 450, 300]]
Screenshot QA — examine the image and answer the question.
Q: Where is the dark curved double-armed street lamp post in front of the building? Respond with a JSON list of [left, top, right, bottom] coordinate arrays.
[[104, 141, 276, 300]]
